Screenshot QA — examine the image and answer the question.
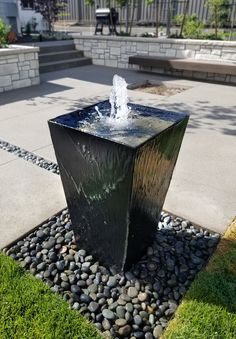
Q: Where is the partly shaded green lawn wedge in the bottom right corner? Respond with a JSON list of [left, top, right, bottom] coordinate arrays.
[[163, 220, 236, 339]]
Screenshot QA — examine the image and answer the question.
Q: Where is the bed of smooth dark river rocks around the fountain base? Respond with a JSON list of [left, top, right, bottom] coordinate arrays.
[[4, 209, 219, 339]]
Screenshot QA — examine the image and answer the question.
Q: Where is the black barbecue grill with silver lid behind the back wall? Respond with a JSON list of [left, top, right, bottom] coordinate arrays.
[[95, 8, 119, 35]]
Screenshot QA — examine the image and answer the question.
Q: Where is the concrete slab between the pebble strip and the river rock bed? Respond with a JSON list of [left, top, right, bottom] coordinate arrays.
[[0, 159, 66, 248]]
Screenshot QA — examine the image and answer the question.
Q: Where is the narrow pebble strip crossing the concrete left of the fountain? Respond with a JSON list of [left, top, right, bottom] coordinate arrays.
[[0, 140, 59, 174]]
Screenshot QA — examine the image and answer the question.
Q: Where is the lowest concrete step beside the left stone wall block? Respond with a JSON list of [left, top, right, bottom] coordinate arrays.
[[39, 57, 92, 73]]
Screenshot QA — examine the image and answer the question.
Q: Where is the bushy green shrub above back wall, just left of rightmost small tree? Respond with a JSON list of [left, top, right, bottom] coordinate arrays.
[[174, 14, 204, 39]]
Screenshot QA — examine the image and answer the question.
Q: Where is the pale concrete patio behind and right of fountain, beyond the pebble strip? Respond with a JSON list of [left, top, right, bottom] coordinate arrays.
[[0, 65, 236, 238]]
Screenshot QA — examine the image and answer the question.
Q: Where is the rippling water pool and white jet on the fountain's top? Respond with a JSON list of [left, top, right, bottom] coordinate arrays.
[[53, 75, 188, 147]]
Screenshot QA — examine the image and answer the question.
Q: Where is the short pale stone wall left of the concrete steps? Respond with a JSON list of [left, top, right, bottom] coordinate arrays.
[[0, 45, 40, 93]]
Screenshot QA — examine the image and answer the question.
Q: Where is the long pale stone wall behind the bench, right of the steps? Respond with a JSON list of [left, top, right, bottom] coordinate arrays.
[[72, 33, 236, 83]]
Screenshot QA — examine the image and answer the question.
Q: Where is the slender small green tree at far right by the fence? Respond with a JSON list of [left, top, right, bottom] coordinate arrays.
[[207, 0, 229, 39]]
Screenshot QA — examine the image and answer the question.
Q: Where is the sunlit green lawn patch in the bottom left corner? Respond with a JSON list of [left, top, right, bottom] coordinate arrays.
[[0, 253, 101, 339]]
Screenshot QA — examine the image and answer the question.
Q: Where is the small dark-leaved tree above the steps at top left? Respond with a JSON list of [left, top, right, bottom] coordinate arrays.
[[21, 0, 67, 32]]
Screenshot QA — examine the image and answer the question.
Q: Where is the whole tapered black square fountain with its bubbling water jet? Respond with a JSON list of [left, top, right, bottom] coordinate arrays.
[[49, 75, 188, 271]]
